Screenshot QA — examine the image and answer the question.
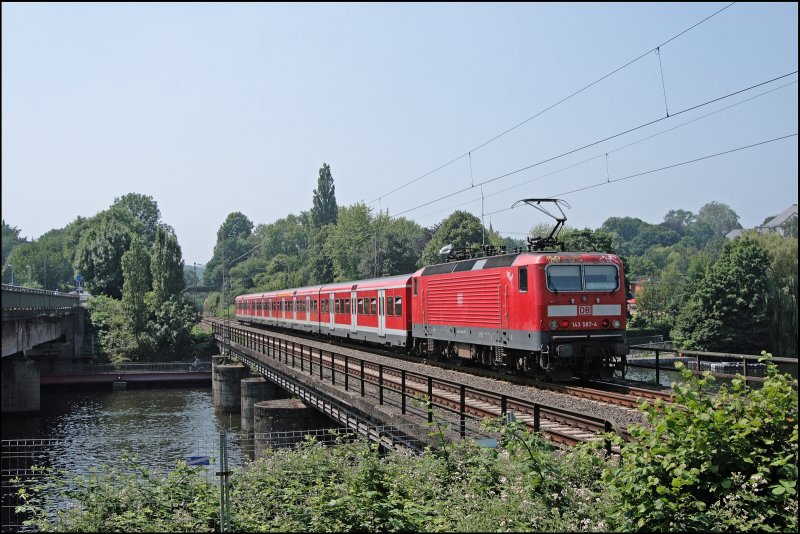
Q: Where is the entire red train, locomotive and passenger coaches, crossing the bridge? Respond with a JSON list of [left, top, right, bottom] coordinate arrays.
[[235, 251, 628, 380]]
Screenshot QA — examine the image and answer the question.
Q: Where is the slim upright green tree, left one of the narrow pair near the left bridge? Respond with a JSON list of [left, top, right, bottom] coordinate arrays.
[[122, 236, 152, 340]]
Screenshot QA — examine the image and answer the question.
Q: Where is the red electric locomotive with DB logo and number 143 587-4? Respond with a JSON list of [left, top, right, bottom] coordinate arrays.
[[411, 252, 627, 378]]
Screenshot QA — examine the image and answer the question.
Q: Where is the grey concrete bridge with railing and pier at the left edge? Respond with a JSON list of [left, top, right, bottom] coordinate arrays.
[[2, 284, 85, 413]]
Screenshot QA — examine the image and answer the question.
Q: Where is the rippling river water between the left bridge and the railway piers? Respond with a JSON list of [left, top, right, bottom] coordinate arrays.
[[2, 387, 241, 472]]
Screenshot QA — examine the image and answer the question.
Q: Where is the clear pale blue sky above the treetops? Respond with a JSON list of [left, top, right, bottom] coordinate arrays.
[[2, 2, 798, 265]]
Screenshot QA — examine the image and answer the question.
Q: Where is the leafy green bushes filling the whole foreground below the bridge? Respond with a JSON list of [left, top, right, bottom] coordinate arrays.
[[20, 362, 798, 532]]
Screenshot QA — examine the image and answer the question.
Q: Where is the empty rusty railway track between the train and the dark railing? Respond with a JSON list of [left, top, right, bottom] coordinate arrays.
[[208, 323, 635, 452]]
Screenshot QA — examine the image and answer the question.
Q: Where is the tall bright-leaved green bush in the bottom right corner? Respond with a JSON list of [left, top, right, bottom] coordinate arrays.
[[603, 362, 798, 532]]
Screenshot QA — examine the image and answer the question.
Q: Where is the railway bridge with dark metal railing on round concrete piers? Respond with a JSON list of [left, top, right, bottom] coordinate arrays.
[[212, 321, 615, 450]]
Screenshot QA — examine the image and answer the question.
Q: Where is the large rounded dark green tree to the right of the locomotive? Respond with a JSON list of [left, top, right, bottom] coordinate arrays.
[[672, 238, 769, 353]]
